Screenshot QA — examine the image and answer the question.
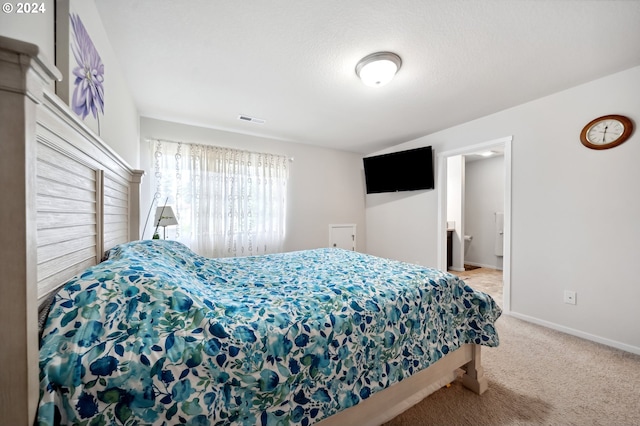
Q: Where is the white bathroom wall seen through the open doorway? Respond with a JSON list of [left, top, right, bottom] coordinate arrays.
[[464, 156, 504, 269]]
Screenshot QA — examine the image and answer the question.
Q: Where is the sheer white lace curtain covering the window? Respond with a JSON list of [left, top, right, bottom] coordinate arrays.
[[150, 140, 289, 257]]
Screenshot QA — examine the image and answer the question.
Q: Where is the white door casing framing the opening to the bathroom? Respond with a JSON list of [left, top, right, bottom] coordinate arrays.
[[437, 136, 513, 313]]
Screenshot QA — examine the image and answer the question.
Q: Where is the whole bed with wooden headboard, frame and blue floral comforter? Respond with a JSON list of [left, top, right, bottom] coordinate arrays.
[[0, 37, 500, 425]]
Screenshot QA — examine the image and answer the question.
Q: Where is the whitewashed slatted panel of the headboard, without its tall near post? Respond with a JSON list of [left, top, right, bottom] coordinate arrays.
[[36, 91, 142, 302]]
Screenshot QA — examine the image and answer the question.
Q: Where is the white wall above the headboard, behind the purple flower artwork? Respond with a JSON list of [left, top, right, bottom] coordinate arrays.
[[0, 0, 140, 168]]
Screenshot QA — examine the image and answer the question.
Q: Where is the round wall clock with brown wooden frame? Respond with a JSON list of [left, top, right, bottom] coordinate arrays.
[[580, 115, 633, 149]]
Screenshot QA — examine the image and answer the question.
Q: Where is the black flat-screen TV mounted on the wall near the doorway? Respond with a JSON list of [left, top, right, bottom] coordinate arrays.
[[362, 146, 434, 194]]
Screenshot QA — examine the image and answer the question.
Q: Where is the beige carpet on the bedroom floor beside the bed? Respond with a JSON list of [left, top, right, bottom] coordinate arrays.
[[387, 268, 640, 426]]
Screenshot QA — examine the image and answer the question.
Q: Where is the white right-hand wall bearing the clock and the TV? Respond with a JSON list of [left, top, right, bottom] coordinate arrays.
[[366, 67, 640, 353]]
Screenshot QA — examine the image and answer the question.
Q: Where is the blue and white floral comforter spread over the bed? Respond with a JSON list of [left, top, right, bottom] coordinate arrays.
[[38, 241, 501, 425]]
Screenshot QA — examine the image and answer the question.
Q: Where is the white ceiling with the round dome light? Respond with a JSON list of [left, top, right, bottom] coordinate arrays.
[[95, 0, 640, 153]]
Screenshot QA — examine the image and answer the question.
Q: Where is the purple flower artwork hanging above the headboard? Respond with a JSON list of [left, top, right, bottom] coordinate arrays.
[[69, 14, 104, 134]]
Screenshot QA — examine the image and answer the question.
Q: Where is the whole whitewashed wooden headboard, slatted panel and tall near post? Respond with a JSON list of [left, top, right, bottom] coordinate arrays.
[[0, 37, 143, 424]]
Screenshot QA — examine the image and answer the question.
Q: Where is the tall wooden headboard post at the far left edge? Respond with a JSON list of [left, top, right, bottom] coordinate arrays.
[[0, 38, 60, 425]]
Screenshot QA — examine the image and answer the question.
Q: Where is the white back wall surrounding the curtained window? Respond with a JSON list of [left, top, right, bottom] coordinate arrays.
[[140, 117, 367, 251]]
